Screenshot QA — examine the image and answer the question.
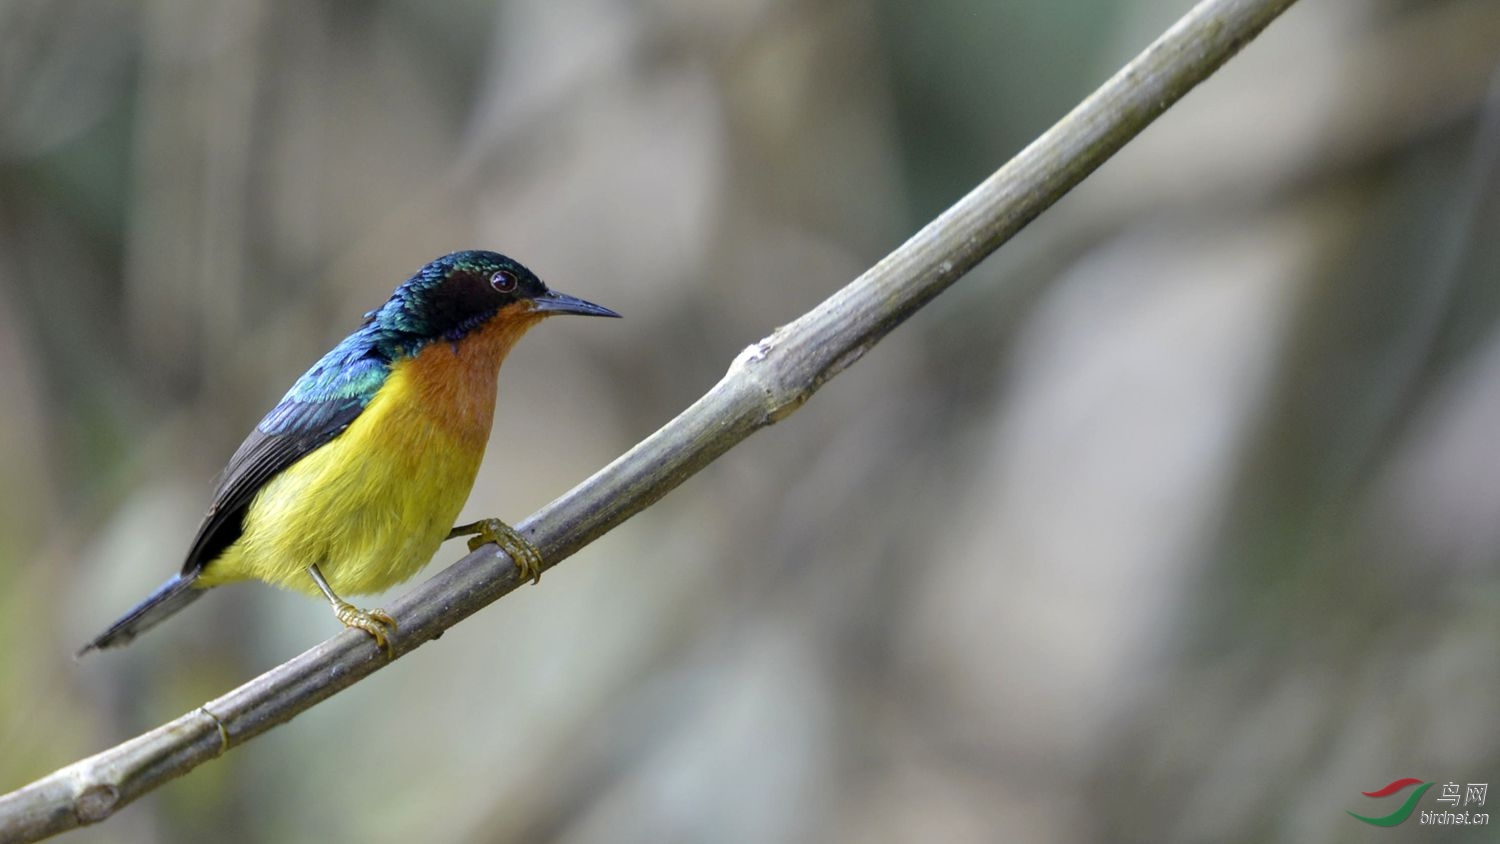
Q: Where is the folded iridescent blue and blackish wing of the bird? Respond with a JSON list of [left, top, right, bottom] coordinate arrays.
[[183, 346, 390, 577]]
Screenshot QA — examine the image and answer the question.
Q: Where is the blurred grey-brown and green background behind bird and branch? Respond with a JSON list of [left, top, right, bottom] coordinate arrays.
[[0, 0, 1500, 844]]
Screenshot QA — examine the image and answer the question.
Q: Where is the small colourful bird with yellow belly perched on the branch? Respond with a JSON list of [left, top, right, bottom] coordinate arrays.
[[78, 250, 620, 657]]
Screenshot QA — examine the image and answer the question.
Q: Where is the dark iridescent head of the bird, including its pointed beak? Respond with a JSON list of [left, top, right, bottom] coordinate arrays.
[[368, 250, 620, 342]]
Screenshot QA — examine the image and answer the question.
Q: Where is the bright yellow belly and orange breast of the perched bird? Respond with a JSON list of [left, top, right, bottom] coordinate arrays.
[[198, 348, 498, 595]]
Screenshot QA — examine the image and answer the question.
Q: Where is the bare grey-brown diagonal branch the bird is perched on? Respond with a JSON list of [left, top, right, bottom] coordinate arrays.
[[0, 0, 1293, 841]]
